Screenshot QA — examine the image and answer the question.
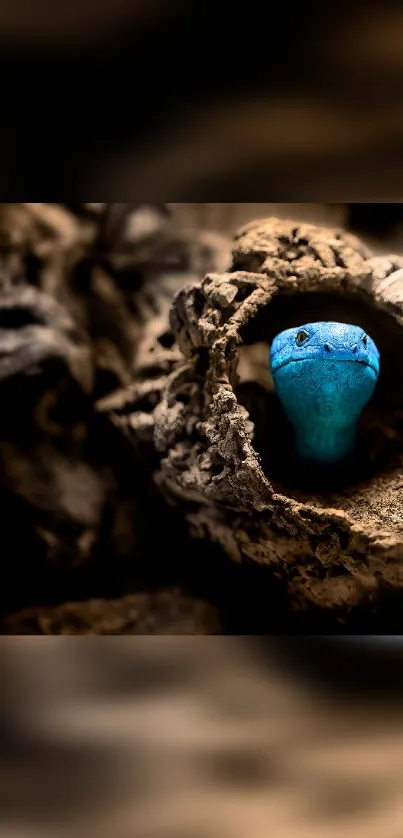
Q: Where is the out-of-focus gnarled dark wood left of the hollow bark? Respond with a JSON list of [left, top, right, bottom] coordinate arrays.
[[0, 203, 228, 631]]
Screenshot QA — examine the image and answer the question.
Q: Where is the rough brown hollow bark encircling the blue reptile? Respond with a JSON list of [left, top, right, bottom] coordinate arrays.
[[155, 218, 403, 620]]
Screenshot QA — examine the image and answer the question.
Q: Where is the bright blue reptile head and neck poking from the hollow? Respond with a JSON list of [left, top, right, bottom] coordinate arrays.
[[270, 322, 379, 465]]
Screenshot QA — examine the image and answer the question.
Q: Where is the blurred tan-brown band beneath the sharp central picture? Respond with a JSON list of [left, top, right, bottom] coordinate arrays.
[[0, 638, 403, 838]]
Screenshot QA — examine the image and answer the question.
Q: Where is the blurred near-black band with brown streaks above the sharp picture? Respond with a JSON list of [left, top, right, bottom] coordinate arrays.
[[0, 0, 403, 202]]
